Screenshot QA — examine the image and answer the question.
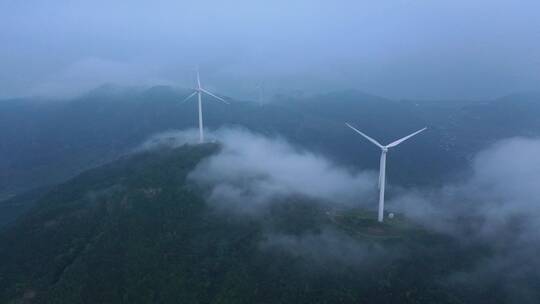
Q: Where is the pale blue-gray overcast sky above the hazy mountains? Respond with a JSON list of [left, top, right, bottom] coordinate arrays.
[[0, 0, 540, 99]]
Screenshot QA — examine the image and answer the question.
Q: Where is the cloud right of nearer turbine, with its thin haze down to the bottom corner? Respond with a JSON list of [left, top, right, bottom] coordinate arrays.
[[389, 138, 540, 303]]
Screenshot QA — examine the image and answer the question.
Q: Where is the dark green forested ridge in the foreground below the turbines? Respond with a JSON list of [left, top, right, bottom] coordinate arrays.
[[0, 144, 494, 303]]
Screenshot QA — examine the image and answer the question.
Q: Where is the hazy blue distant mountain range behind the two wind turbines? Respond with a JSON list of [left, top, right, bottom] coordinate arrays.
[[0, 85, 540, 223]]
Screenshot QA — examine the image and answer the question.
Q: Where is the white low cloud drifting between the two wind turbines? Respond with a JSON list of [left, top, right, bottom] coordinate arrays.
[[189, 129, 375, 213]]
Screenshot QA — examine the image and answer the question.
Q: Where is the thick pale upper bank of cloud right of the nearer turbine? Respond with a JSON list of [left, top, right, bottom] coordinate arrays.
[[389, 138, 540, 237]]
